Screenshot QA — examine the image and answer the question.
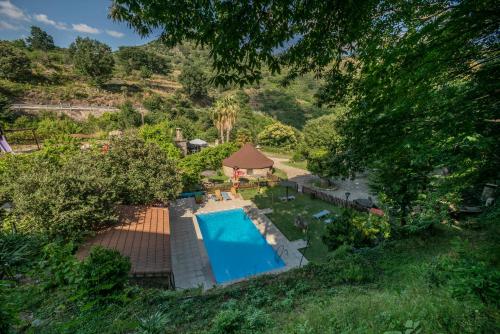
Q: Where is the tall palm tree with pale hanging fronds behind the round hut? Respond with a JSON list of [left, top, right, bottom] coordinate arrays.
[[212, 96, 240, 143]]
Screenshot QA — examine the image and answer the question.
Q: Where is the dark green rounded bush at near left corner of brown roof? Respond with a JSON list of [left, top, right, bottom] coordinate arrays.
[[76, 246, 131, 299]]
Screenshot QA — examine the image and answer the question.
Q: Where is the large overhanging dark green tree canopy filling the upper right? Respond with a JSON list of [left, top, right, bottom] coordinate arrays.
[[111, 0, 500, 221]]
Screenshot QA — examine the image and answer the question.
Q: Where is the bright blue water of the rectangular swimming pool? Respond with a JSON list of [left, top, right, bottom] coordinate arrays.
[[196, 209, 285, 283]]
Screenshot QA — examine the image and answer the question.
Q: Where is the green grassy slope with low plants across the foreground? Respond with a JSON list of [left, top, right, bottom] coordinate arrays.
[[0, 224, 498, 334]]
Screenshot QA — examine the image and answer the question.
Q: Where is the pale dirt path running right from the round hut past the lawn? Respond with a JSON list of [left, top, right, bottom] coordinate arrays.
[[266, 153, 376, 202]]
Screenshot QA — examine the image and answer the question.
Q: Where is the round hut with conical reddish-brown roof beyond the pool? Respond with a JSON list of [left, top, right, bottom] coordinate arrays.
[[222, 144, 274, 177]]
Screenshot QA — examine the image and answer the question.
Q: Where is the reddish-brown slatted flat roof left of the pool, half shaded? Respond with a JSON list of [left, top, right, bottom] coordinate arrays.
[[77, 206, 172, 280]]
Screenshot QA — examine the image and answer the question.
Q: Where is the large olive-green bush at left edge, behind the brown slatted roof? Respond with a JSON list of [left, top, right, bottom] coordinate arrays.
[[5, 151, 116, 239]]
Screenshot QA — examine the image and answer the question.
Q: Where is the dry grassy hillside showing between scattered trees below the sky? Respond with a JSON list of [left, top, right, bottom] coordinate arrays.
[[0, 42, 326, 129]]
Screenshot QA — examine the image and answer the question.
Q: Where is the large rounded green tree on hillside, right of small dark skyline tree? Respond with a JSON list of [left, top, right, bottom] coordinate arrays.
[[69, 37, 115, 85]]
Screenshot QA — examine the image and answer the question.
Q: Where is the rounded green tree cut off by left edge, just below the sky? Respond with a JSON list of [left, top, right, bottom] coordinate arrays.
[[0, 42, 31, 81]]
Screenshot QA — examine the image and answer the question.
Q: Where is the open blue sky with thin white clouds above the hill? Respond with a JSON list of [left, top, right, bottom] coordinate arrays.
[[0, 0, 157, 50]]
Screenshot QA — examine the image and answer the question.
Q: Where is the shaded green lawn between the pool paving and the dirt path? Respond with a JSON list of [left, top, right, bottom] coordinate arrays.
[[241, 186, 341, 262]]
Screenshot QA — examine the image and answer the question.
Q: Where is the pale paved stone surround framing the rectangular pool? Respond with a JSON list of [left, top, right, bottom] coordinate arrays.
[[170, 198, 308, 290]]
